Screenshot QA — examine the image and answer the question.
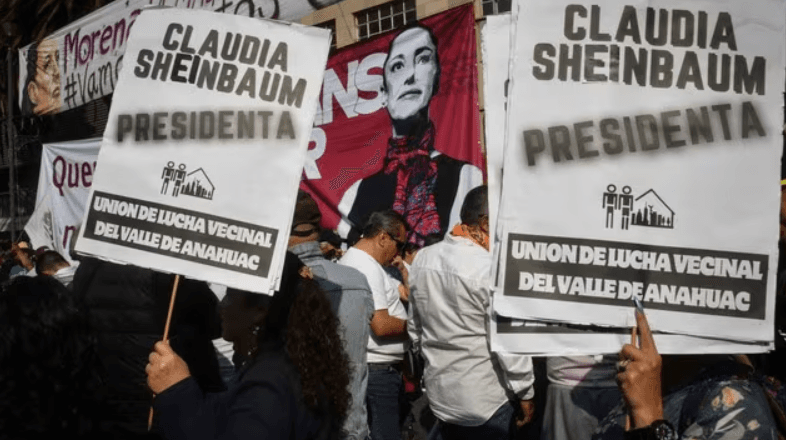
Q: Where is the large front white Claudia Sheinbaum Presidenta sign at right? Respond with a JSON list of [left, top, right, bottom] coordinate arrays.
[[495, 0, 786, 342]]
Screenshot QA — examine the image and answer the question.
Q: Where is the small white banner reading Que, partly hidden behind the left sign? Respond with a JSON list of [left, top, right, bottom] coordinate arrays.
[[25, 139, 101, 260]]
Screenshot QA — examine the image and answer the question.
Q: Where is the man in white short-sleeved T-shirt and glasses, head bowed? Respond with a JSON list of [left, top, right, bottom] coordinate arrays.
[[339, 210, 409, 440]]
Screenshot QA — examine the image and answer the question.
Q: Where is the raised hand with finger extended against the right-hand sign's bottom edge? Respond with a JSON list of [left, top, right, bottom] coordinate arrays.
[[617, 310, 663, 428]]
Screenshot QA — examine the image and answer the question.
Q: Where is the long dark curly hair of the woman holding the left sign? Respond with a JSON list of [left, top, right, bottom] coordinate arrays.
[[253, 252, 351, 429]]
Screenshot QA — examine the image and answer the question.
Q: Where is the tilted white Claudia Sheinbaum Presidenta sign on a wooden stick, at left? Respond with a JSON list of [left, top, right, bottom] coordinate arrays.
[[77, 9, 330, 292]]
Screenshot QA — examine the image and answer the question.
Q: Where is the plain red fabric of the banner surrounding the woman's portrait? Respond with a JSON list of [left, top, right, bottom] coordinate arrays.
[[301, 4, 485, 229]]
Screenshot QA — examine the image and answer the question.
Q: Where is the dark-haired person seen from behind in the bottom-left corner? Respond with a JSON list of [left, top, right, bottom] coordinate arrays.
[[0, 277, 102, 439]]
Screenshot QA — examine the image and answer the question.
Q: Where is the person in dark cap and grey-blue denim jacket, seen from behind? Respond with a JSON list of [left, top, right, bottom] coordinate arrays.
[[289, 190, 374, 440]]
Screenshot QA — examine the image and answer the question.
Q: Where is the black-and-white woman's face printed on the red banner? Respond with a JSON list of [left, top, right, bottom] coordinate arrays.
[[384, 28, 439, 120]]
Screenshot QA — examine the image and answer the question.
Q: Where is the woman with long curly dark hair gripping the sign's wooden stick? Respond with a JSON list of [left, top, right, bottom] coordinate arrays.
[[146, 253, 350, 440]]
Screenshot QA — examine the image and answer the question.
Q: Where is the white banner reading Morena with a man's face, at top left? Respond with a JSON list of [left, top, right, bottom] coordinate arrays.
[[18, 0, 338, 115]]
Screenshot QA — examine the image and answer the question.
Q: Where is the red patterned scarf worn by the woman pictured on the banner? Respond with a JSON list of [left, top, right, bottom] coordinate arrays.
[[385, 123, 440, 246]]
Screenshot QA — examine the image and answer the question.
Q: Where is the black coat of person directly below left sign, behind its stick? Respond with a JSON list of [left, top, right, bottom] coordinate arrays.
[[74, 258, 223, 439]]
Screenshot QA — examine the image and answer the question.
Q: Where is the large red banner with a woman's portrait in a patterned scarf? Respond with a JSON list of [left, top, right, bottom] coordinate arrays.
[[301, 4, 485, 244]]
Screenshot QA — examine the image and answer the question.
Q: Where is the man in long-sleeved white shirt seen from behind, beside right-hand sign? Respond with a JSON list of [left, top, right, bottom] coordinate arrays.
[[408, 185, 535, 440]]
